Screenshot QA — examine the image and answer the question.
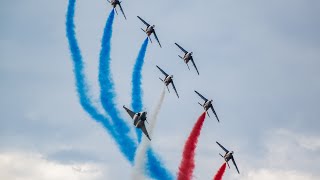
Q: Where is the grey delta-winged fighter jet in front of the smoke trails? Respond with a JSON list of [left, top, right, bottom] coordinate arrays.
[[123, 106, 151, 141]]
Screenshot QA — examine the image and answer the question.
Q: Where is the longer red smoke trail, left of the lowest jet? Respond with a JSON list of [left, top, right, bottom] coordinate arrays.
[[178, 112, 206, 180]]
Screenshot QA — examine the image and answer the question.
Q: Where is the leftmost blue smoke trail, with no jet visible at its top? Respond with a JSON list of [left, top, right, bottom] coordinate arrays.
[[66, 0, 128, 162]]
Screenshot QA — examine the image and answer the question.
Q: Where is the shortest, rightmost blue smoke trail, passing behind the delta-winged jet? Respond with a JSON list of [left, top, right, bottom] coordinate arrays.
[[131, 38, 149, 142]]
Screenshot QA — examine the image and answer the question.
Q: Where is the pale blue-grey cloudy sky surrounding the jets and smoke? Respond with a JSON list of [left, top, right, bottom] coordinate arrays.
[[0, 0, 320, 180]]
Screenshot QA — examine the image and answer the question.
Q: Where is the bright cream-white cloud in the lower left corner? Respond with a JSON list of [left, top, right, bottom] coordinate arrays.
[[0, 152, 108, 180]]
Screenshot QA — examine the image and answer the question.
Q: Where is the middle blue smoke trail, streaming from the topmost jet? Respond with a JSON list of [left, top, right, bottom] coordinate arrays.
[[99, 10, 137, 163]]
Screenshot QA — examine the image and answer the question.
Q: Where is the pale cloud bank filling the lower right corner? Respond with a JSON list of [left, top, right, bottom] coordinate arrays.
[[232, 128, 320, 180]]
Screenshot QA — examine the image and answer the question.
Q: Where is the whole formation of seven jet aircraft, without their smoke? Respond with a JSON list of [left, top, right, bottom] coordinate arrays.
[[107, 0, 240, 174]]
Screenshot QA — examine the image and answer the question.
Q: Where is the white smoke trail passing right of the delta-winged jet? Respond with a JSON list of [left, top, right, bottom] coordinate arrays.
[[132, 87, 166, 180]]
